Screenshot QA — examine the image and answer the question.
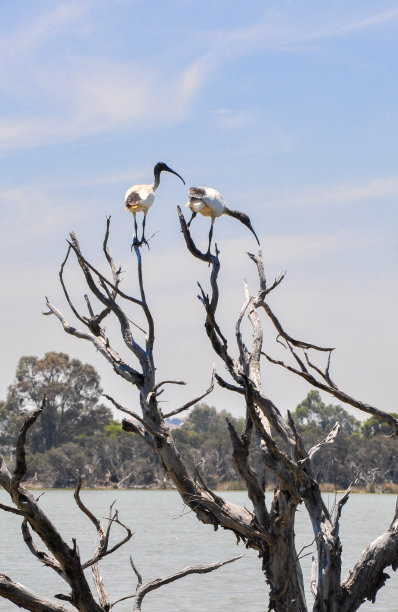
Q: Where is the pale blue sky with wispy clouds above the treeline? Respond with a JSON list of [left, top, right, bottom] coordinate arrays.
[[0, 0, 398, 418]]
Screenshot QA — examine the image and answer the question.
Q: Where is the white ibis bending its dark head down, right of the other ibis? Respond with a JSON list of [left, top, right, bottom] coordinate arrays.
[[186, 187, 260, 253]]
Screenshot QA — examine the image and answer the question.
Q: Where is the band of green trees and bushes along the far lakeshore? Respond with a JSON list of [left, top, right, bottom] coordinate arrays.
[[0, 353, 398, 491]]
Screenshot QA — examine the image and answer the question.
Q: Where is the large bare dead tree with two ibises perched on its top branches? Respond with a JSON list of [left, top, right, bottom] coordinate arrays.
[[41, 209, 398, 612]]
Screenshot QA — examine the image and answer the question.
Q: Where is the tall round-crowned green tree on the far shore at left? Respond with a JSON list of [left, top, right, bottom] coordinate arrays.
[[0, 352, 112, 453]]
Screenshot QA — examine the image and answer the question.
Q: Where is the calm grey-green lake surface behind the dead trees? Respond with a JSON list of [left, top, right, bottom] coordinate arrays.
[[0, 489, 398, 612]]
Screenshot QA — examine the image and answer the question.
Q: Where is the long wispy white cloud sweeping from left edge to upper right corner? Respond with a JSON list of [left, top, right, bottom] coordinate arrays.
[[0, 2, 398, 150]]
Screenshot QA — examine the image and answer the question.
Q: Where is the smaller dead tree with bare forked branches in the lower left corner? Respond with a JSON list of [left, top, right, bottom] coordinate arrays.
[[0, 400, 242, 612]]
